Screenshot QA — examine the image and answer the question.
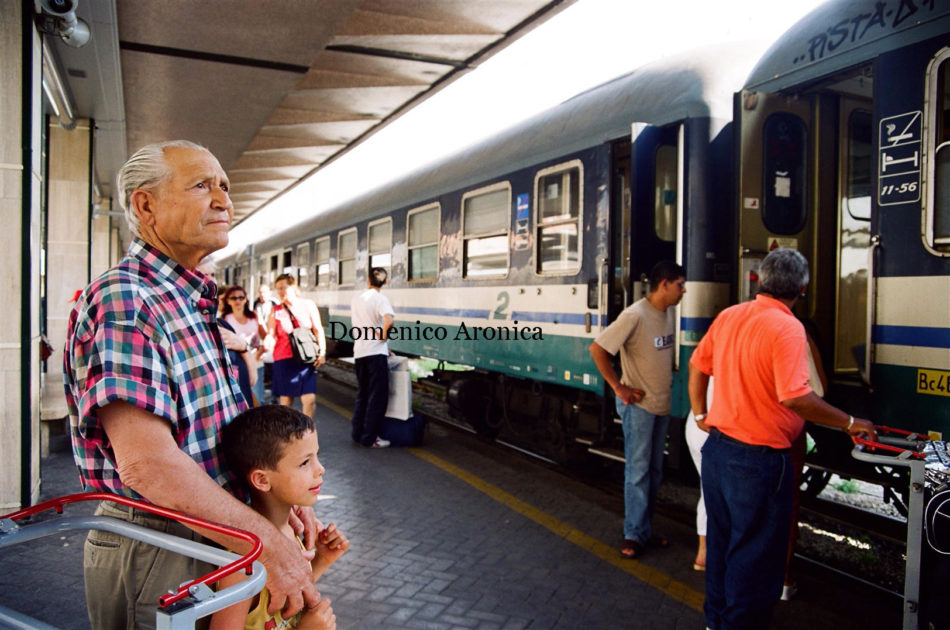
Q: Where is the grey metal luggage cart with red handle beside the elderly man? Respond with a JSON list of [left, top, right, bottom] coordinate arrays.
[[0, 492, 267, 630]]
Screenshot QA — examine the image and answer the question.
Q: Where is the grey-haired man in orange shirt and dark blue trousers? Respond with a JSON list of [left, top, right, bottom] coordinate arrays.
[[689, 249, 876, 630]]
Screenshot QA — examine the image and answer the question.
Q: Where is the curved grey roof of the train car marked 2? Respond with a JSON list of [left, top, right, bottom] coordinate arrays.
[[249, 45, 754, 252]]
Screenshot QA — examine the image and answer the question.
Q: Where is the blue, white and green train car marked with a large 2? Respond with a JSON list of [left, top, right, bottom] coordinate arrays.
[[224, 45, 754, 459]]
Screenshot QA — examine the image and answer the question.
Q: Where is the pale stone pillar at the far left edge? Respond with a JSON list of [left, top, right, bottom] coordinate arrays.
[[0, 2, 42, 512]]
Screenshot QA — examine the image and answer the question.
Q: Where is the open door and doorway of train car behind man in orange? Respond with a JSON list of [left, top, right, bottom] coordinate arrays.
[[735, 81, 874, 492]]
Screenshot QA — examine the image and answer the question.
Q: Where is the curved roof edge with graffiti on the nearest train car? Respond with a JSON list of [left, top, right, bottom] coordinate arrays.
[[745, 0, 950, 92]]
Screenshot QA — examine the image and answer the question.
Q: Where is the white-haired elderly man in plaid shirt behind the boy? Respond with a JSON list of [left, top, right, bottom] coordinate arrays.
[[64, 141, 319, 630]]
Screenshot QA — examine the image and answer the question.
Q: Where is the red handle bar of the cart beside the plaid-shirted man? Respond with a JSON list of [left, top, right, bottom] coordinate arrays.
[[0, 492, 264, 608]]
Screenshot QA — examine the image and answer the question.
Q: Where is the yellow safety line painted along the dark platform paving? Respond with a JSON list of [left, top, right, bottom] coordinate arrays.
[[317, 397, 705, 612]]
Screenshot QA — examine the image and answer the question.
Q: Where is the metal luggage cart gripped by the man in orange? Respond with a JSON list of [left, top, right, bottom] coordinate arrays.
[[851, 427, 950, 630]]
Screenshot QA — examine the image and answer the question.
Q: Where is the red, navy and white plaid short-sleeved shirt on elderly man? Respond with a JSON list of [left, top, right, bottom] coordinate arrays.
[[63, 239, 247, 498]]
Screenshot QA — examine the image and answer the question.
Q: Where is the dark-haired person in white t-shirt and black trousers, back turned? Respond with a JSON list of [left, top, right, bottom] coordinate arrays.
[[350, 267, 395, 448]]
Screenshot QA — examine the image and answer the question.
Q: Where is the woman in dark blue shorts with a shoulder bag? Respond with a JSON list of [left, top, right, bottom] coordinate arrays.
[[267, 273, 327, 418]]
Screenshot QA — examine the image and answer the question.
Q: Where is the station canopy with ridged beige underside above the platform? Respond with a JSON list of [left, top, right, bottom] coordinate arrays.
[[48, 0, 573, 222]]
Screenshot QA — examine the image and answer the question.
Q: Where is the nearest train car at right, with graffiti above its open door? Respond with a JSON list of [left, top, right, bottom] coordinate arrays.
[[735, 0, 950, 488]]
